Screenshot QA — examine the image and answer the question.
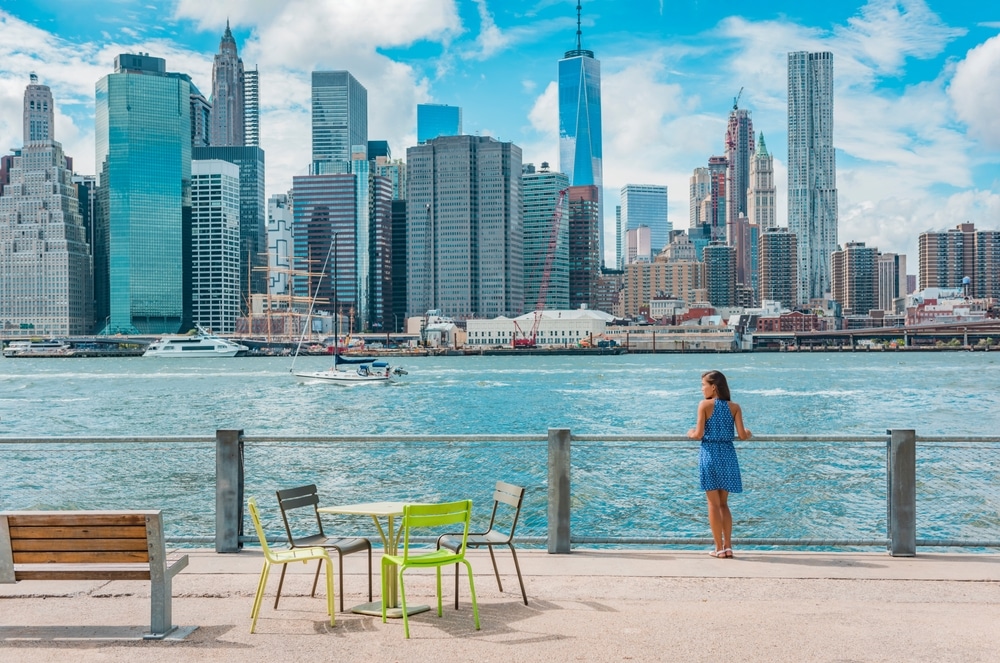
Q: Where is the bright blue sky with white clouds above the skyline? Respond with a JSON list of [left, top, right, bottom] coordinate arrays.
[[0, 0, 1000, 264]]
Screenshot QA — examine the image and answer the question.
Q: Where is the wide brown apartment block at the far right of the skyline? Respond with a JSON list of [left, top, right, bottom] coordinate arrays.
[[918, 223, 1000, 299]]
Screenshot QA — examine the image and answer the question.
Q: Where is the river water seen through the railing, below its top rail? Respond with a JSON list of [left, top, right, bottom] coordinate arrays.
[[0, 429, 1000, 555]]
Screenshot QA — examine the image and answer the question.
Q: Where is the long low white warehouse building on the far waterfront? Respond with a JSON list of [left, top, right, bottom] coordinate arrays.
[[465, 309, 615, 348]]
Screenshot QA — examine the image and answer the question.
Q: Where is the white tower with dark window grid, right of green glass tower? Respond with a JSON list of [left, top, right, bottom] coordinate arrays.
[[191, 159, 240, 334]]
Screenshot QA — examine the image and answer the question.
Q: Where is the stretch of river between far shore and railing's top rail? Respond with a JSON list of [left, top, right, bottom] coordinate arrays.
[[0, 352, 1000, 436]]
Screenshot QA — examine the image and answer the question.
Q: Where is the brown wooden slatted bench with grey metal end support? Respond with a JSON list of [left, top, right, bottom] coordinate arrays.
[[0, 511, 188, 640]]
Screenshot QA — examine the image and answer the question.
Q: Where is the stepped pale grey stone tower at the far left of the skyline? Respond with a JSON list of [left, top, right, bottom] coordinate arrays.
[[0, 74, 94, 337]]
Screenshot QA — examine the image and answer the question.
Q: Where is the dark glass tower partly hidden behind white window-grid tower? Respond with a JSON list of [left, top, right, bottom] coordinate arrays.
[[191, 146, 267, 312]]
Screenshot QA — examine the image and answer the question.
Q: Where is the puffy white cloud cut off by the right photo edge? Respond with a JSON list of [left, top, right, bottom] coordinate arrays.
[[948, 36, 1000, 149]]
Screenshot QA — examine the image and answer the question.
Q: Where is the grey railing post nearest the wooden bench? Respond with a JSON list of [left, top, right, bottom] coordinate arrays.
[[215, 430, 243, 553]]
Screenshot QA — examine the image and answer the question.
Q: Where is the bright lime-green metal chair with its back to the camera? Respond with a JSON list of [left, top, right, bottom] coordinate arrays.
[[382, 500, 479, 638]]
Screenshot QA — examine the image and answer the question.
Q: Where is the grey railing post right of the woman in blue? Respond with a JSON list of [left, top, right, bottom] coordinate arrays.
[[888, 429, 917, 557]]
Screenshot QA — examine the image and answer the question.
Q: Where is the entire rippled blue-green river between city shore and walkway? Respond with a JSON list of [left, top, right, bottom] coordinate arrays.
[[0, 352, 1000, 540]]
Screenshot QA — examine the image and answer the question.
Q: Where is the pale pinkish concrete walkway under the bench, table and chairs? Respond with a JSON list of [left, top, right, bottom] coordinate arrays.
[[0, 550, 1000, 663]]
